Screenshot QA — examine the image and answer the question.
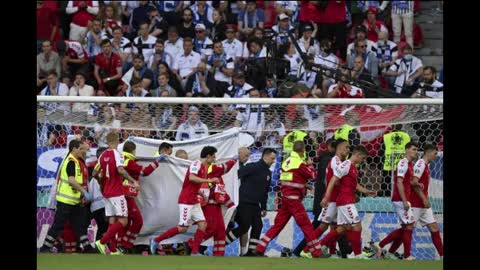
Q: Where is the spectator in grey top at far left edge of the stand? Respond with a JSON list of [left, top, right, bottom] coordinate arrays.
[[37, 40, 61, 89]]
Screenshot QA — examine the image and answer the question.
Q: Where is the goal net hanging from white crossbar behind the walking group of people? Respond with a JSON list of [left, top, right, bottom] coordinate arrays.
[[37, 96, 443, 259]]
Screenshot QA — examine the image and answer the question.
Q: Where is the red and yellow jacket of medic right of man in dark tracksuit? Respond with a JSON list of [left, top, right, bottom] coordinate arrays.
[[280, 152, 317, 200]]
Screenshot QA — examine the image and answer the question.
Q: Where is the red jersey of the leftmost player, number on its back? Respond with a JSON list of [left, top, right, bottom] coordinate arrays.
[[98, 149, 123, 198]]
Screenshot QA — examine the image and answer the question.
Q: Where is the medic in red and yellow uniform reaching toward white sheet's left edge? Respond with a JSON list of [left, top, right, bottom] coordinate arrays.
[[118, 141, 173, 254]]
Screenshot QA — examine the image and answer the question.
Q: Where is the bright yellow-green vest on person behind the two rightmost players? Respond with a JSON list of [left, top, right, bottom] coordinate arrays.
[[383, 131, 410, 171]]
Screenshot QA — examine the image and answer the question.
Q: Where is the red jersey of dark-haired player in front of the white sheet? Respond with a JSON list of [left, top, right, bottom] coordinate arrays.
[[178, 160, 208, 205]]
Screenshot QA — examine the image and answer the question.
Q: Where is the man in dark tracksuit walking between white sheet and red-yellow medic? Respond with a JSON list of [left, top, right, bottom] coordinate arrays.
[[226, 148, 277, 256]]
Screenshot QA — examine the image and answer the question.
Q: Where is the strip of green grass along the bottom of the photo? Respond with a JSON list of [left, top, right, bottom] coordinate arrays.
[[37, 254, 443, 270]]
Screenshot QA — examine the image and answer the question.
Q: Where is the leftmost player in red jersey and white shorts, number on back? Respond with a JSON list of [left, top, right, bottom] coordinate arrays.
[[93, 132, 139, 255]]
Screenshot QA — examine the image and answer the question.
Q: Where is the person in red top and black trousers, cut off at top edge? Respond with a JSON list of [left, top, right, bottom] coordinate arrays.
[[318, 1, 347, 59]]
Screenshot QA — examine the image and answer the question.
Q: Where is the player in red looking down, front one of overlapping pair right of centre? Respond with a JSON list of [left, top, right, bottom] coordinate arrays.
[[320, 145, 377, 259]]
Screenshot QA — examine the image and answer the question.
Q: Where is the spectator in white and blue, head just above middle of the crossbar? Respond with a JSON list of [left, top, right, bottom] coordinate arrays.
[[235, 89, 269, 134]]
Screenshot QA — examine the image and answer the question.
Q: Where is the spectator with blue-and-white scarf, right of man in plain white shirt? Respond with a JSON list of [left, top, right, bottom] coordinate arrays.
[[207, 40, 234, 97]]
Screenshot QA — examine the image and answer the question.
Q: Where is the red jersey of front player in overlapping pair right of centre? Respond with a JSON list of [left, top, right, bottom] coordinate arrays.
[[334, 159, 358, 207]]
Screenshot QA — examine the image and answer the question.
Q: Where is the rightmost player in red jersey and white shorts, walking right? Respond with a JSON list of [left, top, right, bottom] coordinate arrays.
[[410, 144, 443, 258]]
